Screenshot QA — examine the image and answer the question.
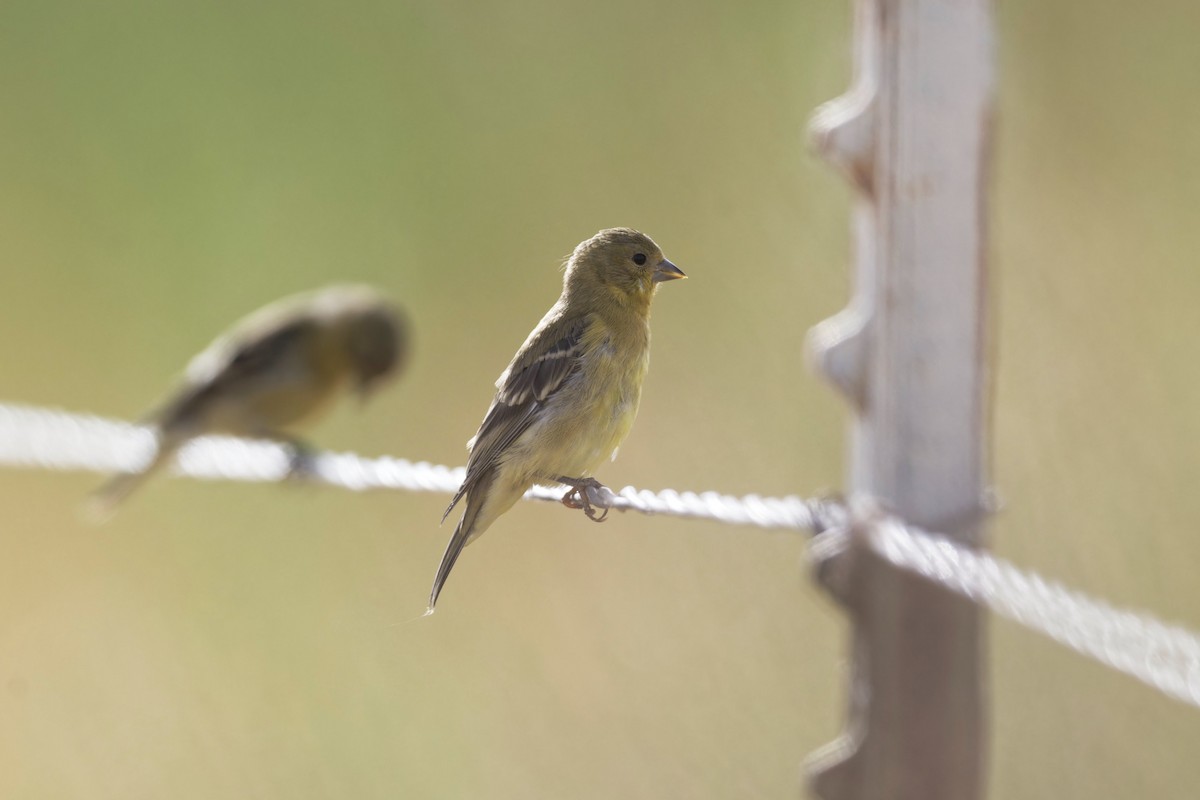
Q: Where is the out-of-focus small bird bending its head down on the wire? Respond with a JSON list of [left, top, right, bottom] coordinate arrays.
[[86, 285, 409, 521]]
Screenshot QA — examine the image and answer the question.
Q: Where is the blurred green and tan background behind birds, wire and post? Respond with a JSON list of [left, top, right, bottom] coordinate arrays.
[[0, 0, 1200, 799]]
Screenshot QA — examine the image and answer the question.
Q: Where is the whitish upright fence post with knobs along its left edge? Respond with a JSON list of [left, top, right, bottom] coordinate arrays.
[[809, 0, 994, 800]]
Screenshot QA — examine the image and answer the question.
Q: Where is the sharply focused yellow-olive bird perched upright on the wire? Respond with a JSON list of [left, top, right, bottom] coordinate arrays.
[[427, 228, 686, 613]]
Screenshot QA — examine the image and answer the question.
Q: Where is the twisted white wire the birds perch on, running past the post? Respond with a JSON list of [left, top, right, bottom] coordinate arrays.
[[0, 403, 1200, 706]]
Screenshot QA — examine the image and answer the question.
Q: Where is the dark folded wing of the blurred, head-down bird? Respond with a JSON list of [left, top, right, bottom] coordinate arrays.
[[156, 317, 316, 428]]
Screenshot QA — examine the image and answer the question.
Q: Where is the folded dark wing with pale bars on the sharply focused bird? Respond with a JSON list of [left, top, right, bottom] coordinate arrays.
[[442, 317, 588, 519]]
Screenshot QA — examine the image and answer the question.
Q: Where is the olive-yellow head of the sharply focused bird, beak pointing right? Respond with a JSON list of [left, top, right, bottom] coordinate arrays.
[[565, 228, 688, 303]]
